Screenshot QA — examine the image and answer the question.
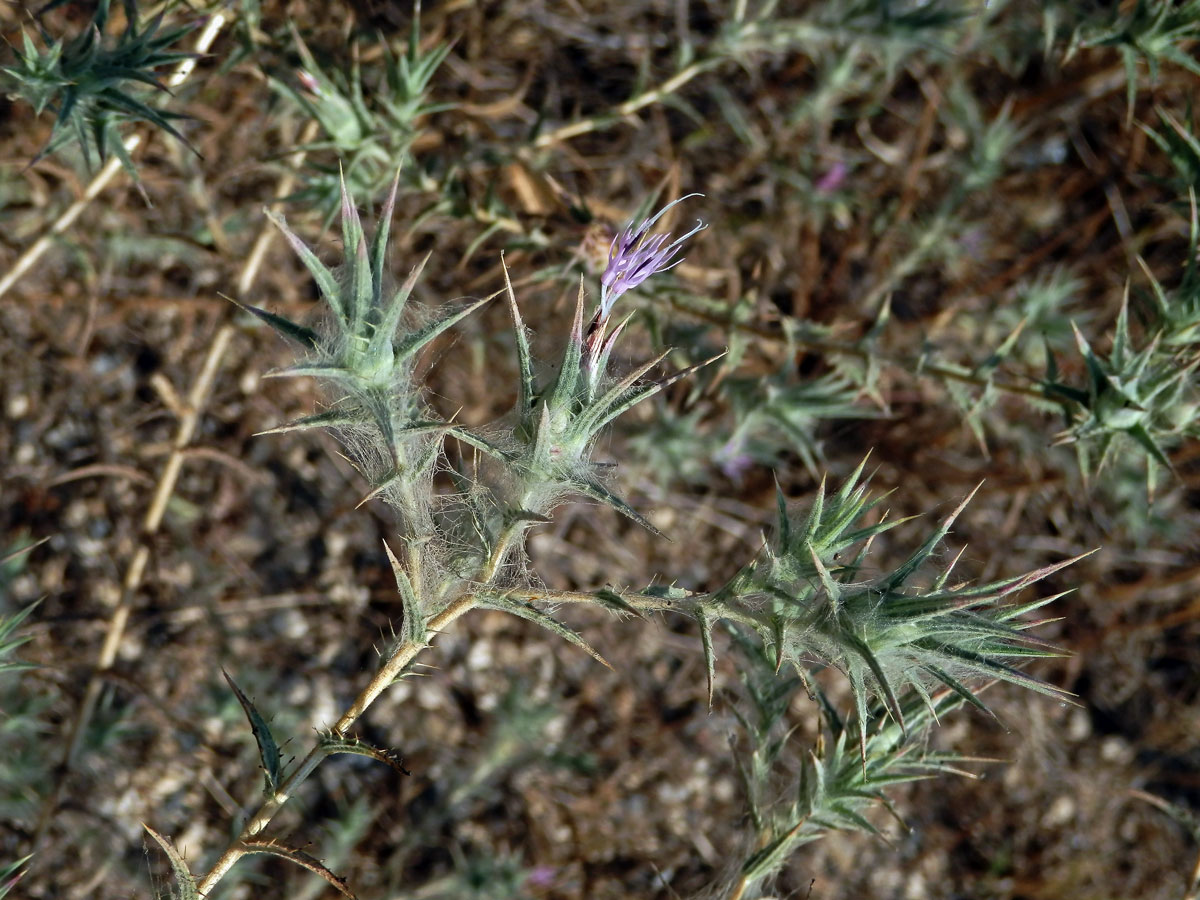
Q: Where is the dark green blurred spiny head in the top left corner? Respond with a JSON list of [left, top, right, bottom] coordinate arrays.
[[0, 0, 194, 182]]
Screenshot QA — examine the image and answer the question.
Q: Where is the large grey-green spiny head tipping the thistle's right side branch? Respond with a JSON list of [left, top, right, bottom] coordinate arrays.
[[694, 461, 1075, 740]]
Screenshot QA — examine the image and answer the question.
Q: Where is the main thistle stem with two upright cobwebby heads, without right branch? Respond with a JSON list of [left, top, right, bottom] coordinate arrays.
[[162, 188, 710, 892]]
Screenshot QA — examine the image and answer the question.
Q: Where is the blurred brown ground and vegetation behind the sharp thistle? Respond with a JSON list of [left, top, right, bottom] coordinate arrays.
[[0, 0, 1200, 900]]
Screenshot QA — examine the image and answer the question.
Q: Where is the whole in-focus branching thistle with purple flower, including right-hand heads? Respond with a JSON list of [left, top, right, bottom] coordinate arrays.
[[142, 175, 1089, 898]]
